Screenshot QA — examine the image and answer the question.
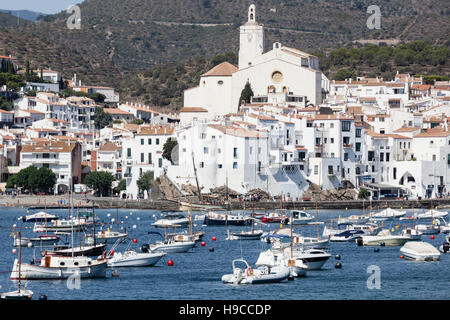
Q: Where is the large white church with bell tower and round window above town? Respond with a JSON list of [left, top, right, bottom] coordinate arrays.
[[180, 4, 329, 124]]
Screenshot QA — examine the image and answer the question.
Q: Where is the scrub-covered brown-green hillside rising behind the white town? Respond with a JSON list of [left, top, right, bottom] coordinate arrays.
[[0, 0, 450, 109]]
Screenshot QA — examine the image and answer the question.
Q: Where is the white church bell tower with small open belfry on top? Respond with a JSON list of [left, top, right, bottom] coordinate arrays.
[[239, 4, 264, 70]]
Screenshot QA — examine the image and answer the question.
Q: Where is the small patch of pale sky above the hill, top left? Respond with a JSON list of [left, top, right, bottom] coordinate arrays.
[[0, 0, 83, 14]]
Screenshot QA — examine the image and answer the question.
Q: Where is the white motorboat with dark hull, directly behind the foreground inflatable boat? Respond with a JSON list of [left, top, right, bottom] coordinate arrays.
[[255, 249, 308, 277]]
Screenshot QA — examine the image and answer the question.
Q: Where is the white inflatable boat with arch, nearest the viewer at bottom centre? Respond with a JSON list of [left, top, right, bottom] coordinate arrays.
[[222, 259, 290, 284]]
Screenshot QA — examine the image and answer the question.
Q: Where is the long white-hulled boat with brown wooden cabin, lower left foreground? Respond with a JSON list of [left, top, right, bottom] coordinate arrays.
[[10, 255, 107, 280]]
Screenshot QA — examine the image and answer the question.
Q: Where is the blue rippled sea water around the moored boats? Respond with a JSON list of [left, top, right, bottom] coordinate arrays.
[[0, 208, 450, 300]]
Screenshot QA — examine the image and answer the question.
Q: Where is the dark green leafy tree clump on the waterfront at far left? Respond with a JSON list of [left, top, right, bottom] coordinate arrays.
[[6, 166, 57, 194]]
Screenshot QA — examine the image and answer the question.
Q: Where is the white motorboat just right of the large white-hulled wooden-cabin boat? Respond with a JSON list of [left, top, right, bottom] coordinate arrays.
[[106, 241, 166, 268]]
